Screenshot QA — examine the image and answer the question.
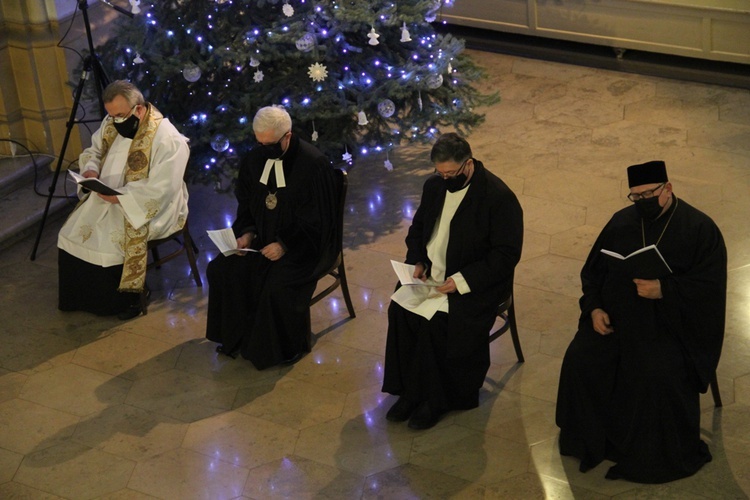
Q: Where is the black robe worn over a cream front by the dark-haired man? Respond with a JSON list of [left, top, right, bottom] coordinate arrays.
[[383, 160, 523, 411]]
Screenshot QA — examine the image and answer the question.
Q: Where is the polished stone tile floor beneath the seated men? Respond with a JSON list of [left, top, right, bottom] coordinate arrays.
[[0, 48, 750, 499]]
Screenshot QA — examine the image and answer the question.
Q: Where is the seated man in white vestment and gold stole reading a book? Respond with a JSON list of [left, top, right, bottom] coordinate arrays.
[[57, 80, 190, 319]]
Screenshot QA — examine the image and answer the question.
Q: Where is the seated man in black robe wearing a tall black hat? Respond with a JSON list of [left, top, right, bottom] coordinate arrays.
[[557, 161, 727, 483]]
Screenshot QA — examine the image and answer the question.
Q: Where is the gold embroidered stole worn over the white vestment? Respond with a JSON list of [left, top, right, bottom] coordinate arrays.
[[102, 104, 164, 293]]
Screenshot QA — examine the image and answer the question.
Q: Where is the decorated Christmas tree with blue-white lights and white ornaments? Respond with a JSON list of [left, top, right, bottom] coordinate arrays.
[[98, 0, 498, 182]]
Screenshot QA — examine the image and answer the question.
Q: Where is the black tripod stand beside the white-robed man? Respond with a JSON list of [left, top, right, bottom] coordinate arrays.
[[31, 0, 111, 260]]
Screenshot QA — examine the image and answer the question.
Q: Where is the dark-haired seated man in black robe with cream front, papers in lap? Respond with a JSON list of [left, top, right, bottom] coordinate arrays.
[[383, 133, 523, 429]]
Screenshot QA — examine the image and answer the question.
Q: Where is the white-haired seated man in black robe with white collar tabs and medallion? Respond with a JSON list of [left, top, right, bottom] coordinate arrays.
[[206, 106, 338, 370]]
